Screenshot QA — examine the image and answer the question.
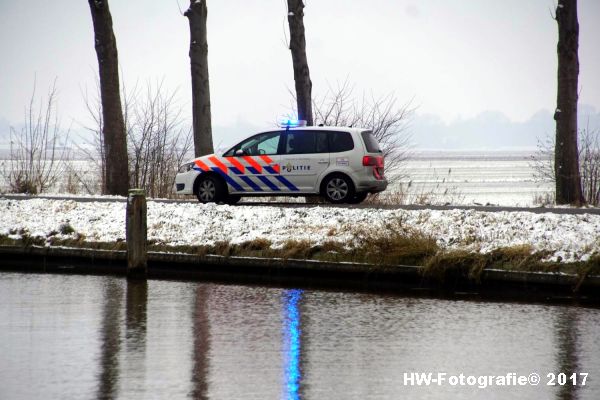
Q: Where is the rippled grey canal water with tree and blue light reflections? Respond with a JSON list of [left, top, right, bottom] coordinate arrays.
[[0, 273, 600, 400]]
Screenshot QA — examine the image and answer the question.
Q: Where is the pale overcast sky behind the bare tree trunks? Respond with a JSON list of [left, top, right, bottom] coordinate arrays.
[[0, 0, 600, 148]]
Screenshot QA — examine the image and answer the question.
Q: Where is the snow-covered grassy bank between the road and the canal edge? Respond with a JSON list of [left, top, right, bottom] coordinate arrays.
[[0, 199, 600, 261]]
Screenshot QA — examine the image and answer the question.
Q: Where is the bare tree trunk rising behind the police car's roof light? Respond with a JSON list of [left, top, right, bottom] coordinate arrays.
[[287, 0, 313, 126]]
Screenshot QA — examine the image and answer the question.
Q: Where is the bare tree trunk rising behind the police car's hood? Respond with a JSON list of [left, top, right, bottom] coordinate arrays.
[[183, 0, 214, 157]]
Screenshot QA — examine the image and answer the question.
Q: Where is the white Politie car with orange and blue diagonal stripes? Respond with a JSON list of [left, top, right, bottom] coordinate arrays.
[[175, 123, 388, 204]]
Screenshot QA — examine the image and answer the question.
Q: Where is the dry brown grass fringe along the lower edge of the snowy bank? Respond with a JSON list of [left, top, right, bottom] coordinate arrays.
[[0, 230, 600, 281]]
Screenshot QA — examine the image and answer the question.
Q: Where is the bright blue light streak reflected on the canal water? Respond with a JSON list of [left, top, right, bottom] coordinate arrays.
[[283, 289, 303, 400]]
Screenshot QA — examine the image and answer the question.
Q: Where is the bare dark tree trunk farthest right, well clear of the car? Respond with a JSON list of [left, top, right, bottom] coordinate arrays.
[[554, 0, 584, 205]]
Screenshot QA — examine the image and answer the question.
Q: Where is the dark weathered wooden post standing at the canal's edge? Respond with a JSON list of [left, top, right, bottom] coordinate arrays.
[[125, 189, 148, 279]]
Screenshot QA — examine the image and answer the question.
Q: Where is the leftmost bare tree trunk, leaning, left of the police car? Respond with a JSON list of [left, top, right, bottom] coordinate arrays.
[[88, 0, 129, 196]]
